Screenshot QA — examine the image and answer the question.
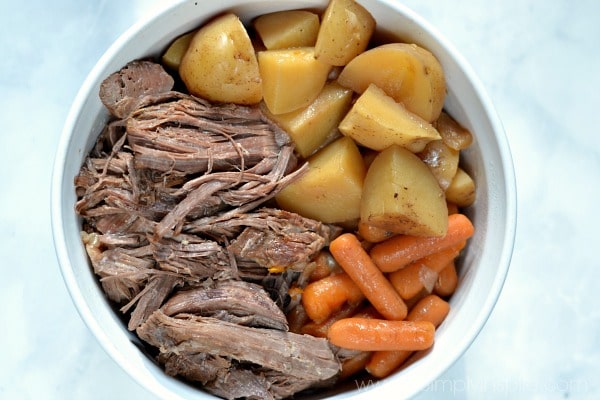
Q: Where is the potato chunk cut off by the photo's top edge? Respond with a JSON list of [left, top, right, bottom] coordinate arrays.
[[315, 0, 375, 66]]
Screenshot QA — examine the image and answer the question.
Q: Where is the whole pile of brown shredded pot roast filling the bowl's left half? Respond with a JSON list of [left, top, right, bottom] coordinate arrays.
[[75, 61, 344, 399]]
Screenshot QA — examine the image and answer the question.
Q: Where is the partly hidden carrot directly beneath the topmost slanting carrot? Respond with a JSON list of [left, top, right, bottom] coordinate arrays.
[[388, 243, 463, 300]]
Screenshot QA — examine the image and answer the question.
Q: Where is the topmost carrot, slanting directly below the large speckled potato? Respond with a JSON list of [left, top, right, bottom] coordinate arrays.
[[370, 214, 475, 272]]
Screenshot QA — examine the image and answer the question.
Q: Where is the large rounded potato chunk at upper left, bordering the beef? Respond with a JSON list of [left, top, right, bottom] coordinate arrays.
[[179, 14, 262, 104]]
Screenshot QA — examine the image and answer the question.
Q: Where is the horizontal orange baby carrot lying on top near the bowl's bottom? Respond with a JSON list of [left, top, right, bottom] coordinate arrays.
[[327, 317, 435, 351]]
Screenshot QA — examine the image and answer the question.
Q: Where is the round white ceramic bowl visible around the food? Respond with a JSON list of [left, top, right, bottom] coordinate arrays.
[[52, 0, 516, 399]]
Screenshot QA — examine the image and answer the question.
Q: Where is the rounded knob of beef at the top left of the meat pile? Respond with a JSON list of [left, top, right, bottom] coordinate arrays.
[[99, 60, 175, 118]]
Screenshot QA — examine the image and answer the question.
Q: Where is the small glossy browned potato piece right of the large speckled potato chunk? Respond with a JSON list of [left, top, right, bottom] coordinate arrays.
[[418, 139, 460, 190]]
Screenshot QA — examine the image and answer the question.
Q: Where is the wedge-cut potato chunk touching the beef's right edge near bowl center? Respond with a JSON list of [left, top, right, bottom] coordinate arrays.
[[275, 137, 365, 223]]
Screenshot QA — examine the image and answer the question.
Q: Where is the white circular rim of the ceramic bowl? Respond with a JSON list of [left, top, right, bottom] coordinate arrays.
[[51, 0, 517, 398]]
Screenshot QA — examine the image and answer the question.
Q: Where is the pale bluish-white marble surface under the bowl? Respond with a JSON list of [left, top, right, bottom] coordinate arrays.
[[0, 0, 600, 399]]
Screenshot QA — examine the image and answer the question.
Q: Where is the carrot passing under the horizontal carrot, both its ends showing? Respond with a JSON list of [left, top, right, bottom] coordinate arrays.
[[365, 295, 450, 378]]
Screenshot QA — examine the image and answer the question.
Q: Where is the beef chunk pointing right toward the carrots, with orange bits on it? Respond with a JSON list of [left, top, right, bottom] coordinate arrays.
[[188, 207, 340, 313]]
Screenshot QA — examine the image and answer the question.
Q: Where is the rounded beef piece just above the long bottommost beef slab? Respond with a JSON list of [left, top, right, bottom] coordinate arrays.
[[161, 280, 288, 331]]
